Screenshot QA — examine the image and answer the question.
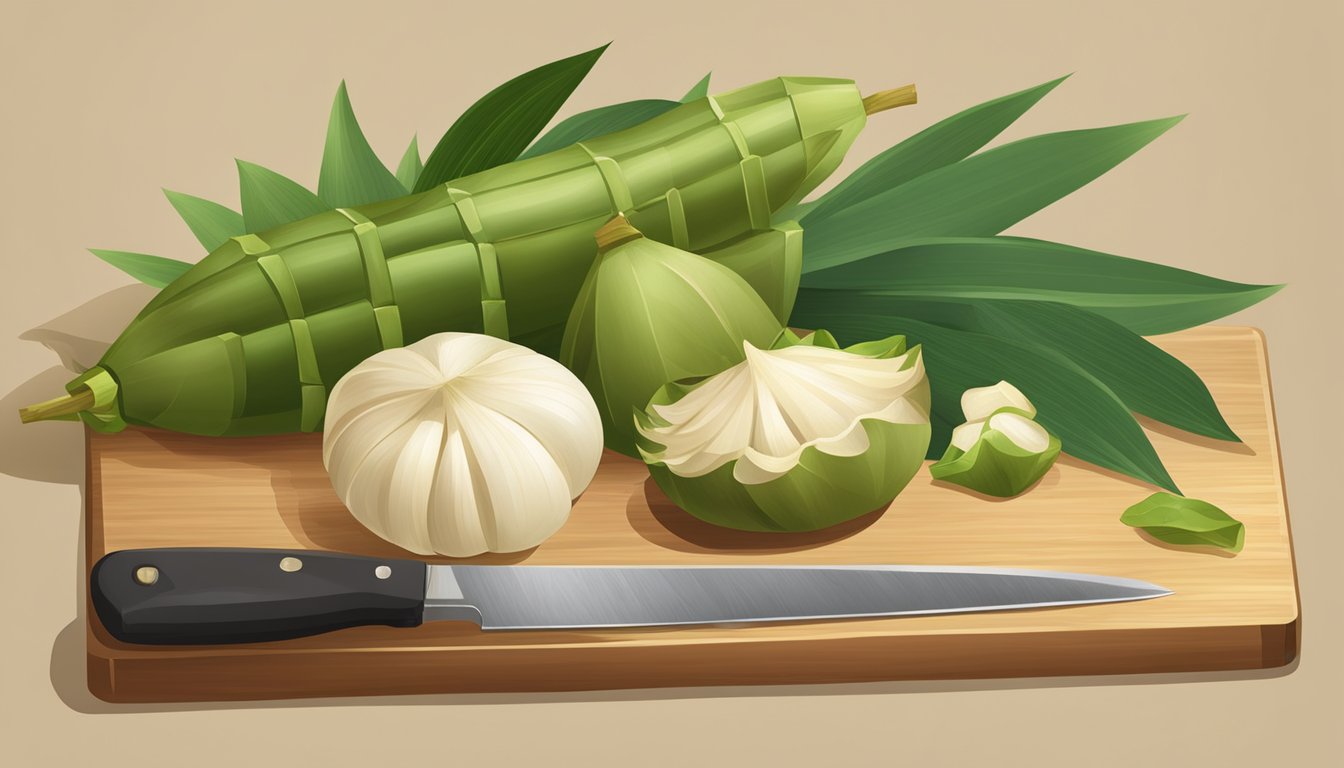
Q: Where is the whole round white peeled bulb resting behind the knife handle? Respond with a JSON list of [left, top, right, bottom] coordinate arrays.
[[323, 334, 602, 557]]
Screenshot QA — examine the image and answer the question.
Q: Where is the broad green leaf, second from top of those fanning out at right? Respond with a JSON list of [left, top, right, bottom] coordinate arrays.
[[802, 117, 1181, 272]]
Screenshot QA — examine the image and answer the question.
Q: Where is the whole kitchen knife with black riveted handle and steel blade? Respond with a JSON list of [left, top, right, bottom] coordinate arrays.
[[89, 547, 1171, 644]]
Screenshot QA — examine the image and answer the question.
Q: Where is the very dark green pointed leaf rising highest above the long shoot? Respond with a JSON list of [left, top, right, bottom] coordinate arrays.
[[415, 46, 606, 192]]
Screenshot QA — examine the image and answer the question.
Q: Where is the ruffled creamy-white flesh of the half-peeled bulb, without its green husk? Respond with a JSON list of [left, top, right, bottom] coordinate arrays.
[[640, 342, 929, 486]]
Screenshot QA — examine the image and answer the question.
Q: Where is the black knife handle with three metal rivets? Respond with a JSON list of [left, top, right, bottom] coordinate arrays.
[[89, 547, 426, 644]]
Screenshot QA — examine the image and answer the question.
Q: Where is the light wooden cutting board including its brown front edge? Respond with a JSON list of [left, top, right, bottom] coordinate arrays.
[[86, 327, 1298, 702]]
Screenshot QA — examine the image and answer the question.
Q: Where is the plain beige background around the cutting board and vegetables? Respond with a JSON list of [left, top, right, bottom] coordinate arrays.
[[0, 0, 1344, 765]]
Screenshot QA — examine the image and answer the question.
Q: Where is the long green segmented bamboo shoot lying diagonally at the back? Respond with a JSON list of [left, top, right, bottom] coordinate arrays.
[[28, 78, 914, 436]]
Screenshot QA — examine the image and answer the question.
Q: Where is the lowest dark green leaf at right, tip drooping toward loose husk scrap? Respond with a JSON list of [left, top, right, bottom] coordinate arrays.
[[792, 289, 1180, 492]]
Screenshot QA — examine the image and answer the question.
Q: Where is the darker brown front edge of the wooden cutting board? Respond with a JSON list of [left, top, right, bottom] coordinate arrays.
[[87, 620, 1301, 703]]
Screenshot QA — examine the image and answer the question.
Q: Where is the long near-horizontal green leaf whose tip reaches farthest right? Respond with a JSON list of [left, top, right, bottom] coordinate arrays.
[[802, 230, 1282, 336]]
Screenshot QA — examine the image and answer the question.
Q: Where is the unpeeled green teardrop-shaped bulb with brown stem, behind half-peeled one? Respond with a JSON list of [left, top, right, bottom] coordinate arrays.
[[559, 217, 782, 456]]
